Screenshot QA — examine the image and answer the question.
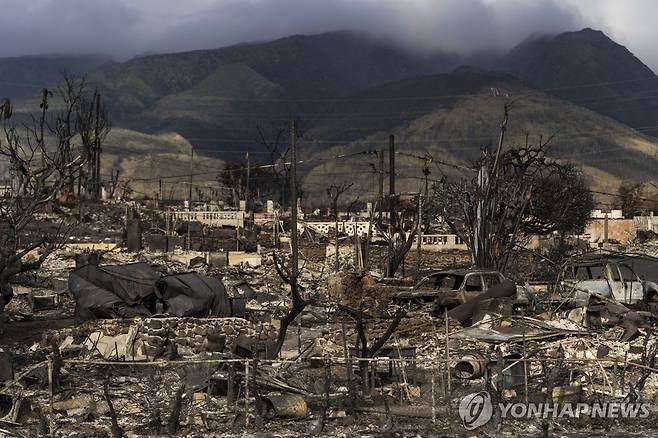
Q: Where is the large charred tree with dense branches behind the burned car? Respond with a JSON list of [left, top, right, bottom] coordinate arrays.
[[434, 106, 594, 270]]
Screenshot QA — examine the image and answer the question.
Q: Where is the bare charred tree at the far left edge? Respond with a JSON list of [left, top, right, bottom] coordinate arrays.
[[0, 78, 106, 312]]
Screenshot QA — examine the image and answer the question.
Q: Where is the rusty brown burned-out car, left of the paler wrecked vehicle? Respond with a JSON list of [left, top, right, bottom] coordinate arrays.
[[393, 269, 532, 310]]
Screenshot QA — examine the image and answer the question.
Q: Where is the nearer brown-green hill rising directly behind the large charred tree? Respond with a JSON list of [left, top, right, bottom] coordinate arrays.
[[300, 68, 658, 201]]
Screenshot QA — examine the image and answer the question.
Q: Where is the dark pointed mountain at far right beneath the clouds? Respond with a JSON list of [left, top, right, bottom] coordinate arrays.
[[496, 28, 658, 135]]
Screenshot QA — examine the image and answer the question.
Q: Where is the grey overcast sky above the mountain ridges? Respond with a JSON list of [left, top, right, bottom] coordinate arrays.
[[0, 0, 658, 71]]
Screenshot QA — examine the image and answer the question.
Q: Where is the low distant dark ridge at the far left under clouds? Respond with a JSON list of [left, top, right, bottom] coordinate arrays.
[[0, 55, 113, 99]]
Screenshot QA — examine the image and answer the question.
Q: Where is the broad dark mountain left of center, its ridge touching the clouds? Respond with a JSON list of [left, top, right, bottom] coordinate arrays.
[[86, 32, 458, 157]]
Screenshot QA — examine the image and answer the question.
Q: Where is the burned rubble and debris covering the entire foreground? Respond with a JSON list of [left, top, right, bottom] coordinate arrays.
[[0, 207, 658, 437]]
